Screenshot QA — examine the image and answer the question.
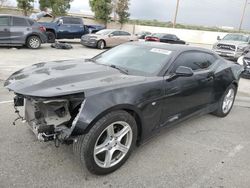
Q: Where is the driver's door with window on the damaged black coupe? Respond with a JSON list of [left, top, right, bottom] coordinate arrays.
[[162, 51, 216, 124]]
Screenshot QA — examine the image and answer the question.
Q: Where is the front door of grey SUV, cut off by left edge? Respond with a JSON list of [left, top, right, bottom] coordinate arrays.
[[0, 16, 10, 44]]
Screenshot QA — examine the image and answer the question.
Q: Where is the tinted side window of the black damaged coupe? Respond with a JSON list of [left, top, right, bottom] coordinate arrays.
[[171, 52, 216, 72]]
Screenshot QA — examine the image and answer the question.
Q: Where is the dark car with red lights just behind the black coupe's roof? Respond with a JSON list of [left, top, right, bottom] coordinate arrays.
[[145, 33, 186, 44]]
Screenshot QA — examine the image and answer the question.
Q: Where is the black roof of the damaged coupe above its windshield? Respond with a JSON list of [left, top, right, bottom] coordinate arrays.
[[129, 41, 214, 54]]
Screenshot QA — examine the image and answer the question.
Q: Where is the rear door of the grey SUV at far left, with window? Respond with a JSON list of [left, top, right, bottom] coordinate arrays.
[[10, 16, 32, 44]]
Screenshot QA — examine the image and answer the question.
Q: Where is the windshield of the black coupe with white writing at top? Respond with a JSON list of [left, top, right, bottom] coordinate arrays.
[[93, 44, 172, 76]]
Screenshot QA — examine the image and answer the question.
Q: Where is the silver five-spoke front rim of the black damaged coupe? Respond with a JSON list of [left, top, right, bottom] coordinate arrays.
[[94, 121, 133, 168]]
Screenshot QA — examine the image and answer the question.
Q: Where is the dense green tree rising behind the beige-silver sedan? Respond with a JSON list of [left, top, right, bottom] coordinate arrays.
[[89, 0, 113, 26]]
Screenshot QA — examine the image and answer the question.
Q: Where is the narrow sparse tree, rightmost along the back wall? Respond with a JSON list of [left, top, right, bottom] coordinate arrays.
[[115, 0, 130, 28]]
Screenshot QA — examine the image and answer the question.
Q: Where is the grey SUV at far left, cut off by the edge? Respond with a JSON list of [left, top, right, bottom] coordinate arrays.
[[0, 14, 47, 49]]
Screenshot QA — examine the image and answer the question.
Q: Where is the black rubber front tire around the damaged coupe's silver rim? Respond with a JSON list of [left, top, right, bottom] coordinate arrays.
[[73, 111, 137, 175]]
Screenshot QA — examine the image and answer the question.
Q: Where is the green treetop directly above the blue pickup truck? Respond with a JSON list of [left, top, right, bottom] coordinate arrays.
[[39, 0, 73, 16]]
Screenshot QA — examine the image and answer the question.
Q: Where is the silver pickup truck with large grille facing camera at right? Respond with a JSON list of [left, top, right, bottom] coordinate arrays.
[[213, 34, 250, 60]]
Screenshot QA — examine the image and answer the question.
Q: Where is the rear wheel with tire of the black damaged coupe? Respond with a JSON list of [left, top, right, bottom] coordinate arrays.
[[213, 84, 237, 117]]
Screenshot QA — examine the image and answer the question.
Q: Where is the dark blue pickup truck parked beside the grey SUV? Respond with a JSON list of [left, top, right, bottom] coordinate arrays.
[[40, 16, 89, 43]]
